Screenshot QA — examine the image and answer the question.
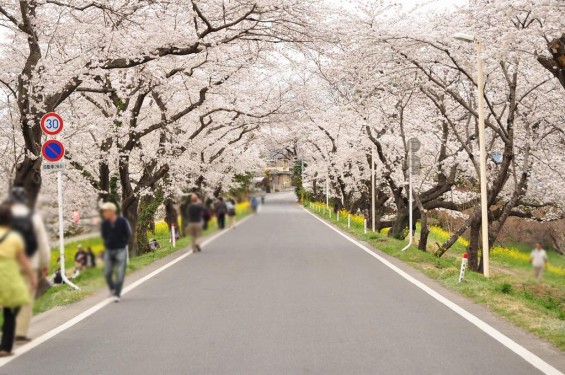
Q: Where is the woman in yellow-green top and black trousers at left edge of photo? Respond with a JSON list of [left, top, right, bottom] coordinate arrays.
[[0, 203, 37, 358]]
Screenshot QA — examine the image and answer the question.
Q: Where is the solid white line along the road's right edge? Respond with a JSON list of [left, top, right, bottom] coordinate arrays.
[[304, 208, 565, 375]]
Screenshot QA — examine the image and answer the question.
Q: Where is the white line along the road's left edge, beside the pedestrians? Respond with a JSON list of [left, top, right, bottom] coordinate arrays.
[[0, 215, 253, 368]]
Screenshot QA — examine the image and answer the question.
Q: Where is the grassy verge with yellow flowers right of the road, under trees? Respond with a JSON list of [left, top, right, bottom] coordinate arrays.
[[306, 203, 565, 351]]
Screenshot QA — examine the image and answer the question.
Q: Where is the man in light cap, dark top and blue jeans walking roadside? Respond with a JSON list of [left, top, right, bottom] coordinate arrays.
[[101, 202, 131, 302]]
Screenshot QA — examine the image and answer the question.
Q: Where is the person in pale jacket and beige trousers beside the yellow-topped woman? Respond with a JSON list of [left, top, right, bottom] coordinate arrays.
[[10, 187, 51, 344]]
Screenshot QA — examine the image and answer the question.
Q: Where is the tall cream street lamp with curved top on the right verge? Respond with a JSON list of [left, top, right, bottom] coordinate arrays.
[[453, 33, 490, 277]]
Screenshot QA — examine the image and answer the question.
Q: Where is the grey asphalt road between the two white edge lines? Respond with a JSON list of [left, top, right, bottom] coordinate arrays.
[[0, 195, 539, 375]]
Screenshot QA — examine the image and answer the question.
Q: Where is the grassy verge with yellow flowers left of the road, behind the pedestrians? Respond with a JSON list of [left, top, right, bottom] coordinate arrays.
[[34, 203, 250, 314]]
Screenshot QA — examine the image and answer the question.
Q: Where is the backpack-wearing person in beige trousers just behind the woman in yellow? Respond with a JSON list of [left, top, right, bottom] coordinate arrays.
[[9, 187, 51, 344]]
